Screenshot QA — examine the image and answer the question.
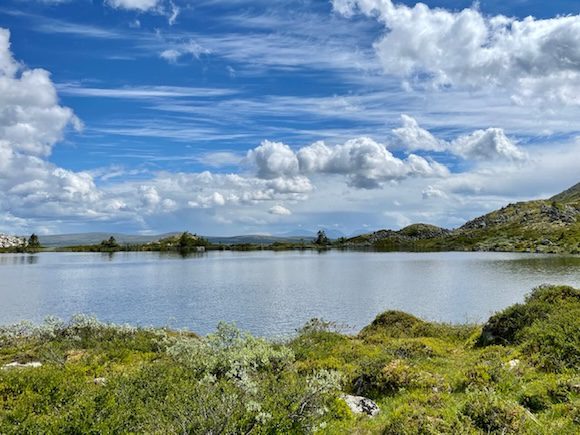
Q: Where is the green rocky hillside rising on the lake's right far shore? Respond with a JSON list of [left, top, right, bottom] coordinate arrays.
[[347, 183, 580, 254]]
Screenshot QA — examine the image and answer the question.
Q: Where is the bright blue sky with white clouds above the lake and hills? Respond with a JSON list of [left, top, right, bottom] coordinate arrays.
[[0, 0, 580, 235]]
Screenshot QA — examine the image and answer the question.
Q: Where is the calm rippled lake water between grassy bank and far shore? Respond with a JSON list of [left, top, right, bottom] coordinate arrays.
[[0, 251, 580, 336]]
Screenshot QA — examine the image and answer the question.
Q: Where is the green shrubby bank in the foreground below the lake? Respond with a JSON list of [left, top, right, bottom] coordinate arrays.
[[0, 287, 580, 434]]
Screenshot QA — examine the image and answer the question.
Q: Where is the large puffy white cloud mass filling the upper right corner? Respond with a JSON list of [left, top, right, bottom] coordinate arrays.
[[332, 0, 580, 105]]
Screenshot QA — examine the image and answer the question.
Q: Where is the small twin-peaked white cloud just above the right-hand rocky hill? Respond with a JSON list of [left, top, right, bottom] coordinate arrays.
[[393, 115, 527, 161]]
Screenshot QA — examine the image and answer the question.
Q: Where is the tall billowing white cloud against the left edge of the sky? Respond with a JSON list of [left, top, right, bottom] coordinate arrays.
[[0, 29, 108, 223]]
